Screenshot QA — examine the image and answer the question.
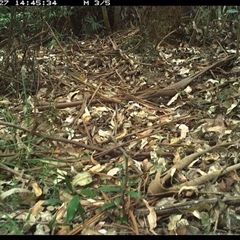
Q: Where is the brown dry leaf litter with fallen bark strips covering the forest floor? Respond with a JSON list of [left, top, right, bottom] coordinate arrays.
[[0, 29, 240, 235]]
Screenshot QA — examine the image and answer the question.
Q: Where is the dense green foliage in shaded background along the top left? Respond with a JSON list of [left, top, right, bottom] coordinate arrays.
[[0, 6, 104, 42]]
